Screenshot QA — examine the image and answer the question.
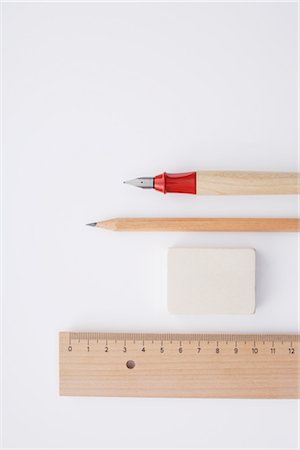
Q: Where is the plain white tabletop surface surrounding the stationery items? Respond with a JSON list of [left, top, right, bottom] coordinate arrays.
[[3, 3, 299, 449]]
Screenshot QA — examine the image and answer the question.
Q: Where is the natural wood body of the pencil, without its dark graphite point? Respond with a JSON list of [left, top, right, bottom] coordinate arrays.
[[96, 217, 300, 232]]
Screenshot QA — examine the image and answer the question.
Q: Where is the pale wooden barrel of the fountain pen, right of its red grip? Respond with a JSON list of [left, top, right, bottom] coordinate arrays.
[[196, 171, 300, 195]]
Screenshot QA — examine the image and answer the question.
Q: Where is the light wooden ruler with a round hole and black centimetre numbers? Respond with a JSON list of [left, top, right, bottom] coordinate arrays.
[[59, 332, 300, 398]]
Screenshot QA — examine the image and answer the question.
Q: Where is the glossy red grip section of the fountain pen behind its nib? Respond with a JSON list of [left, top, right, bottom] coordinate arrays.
[[154, 172, 196, 194]]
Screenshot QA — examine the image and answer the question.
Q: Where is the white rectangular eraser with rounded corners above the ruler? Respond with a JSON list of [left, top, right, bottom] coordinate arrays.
[[167, 248, 255, 314]]
